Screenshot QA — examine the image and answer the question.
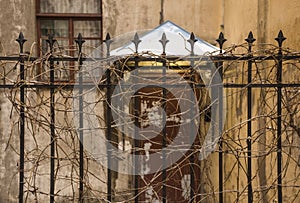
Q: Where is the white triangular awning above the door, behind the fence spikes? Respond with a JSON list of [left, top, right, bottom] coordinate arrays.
[[110, 21, 219, 56]]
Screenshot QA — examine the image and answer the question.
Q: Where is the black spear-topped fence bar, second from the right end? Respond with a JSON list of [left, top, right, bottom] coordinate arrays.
[[245, 32, 255, 203]]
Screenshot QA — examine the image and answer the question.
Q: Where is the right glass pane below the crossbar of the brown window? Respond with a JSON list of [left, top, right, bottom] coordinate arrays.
[[74, 21, 101, 38]]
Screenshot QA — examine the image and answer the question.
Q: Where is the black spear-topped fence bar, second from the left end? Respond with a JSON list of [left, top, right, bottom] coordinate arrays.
[[47, 35, 56, 203]]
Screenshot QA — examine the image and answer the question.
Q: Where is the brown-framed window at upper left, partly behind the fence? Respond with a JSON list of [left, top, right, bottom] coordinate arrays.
[[36, 0, 102, 81]]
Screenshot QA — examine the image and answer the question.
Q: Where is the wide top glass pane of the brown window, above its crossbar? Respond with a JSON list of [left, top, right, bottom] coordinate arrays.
[[40, 0, 101, 13]]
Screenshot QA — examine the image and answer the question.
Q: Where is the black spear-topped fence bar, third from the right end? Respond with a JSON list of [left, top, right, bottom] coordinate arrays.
[[216, 32, 227, 203]]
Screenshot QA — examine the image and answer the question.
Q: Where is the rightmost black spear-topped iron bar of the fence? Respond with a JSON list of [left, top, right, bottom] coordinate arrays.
[[275, 30, 286, 203]]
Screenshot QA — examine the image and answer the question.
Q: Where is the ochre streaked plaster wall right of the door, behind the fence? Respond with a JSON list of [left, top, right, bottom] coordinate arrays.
[[220, 0, 300, 202]]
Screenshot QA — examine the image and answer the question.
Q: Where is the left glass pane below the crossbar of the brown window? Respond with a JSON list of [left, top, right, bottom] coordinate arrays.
[[41, 20, 69, 37]]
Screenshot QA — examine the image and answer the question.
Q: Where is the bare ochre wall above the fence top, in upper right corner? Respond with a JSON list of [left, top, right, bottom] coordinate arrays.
[[224, 0, 300, 49]]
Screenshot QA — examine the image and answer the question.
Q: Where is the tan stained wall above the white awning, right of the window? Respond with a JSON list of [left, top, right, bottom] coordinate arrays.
[[103, 0, 222, 44]]
